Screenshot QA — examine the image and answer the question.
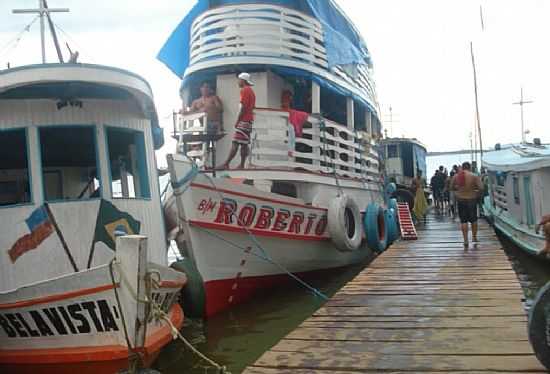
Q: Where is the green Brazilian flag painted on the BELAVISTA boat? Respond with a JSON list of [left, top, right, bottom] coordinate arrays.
[[92, 199, 141, 251]]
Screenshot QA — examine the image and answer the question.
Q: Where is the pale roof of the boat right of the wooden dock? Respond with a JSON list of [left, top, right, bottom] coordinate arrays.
[[483, 144, 550, 172]]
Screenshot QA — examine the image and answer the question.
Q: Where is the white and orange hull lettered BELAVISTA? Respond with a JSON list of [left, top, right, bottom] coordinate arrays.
[[0, 265, 185, 374]]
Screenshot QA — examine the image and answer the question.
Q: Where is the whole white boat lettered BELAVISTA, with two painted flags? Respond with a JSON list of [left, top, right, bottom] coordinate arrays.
[[0, 64, 186, 374]]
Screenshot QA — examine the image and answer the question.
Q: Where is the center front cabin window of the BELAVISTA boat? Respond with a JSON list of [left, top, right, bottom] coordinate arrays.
[[38, 126, 100, 201]]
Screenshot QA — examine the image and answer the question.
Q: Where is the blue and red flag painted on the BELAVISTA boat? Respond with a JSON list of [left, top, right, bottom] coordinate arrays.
[[8, 205, 54, 263]]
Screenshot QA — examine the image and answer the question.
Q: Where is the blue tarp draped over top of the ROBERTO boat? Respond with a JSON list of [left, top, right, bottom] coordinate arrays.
[[157, 0, 371, 77]]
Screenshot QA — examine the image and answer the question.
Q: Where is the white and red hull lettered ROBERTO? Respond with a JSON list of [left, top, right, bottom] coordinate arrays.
[[165, 156, 384, 317]]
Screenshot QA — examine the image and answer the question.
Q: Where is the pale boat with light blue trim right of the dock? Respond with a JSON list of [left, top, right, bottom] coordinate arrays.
[[483, 139, 550, 255]]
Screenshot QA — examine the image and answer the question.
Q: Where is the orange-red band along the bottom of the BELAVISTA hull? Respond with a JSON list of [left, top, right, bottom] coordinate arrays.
[[0, 304, 183, 374]]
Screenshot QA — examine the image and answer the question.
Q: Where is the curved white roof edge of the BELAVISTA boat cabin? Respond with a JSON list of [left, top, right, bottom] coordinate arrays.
[[0, 63, 163, 148]]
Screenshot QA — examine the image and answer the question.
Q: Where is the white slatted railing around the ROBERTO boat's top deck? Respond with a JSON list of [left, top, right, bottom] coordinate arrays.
[[189, 4, 376, 103]]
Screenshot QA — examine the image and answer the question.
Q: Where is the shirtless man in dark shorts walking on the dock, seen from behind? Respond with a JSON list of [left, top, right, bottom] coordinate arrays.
[[451, 162, 483, 248]]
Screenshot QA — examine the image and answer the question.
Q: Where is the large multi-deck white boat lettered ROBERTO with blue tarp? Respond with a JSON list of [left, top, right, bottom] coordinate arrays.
[[159, 0, 393, 316]]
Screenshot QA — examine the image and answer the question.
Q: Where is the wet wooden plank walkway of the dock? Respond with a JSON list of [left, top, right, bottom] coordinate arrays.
[[244, 215, 547, 374]]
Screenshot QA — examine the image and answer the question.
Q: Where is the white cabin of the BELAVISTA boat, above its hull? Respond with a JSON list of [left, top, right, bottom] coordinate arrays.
[[0, 64, 166, 291]]
